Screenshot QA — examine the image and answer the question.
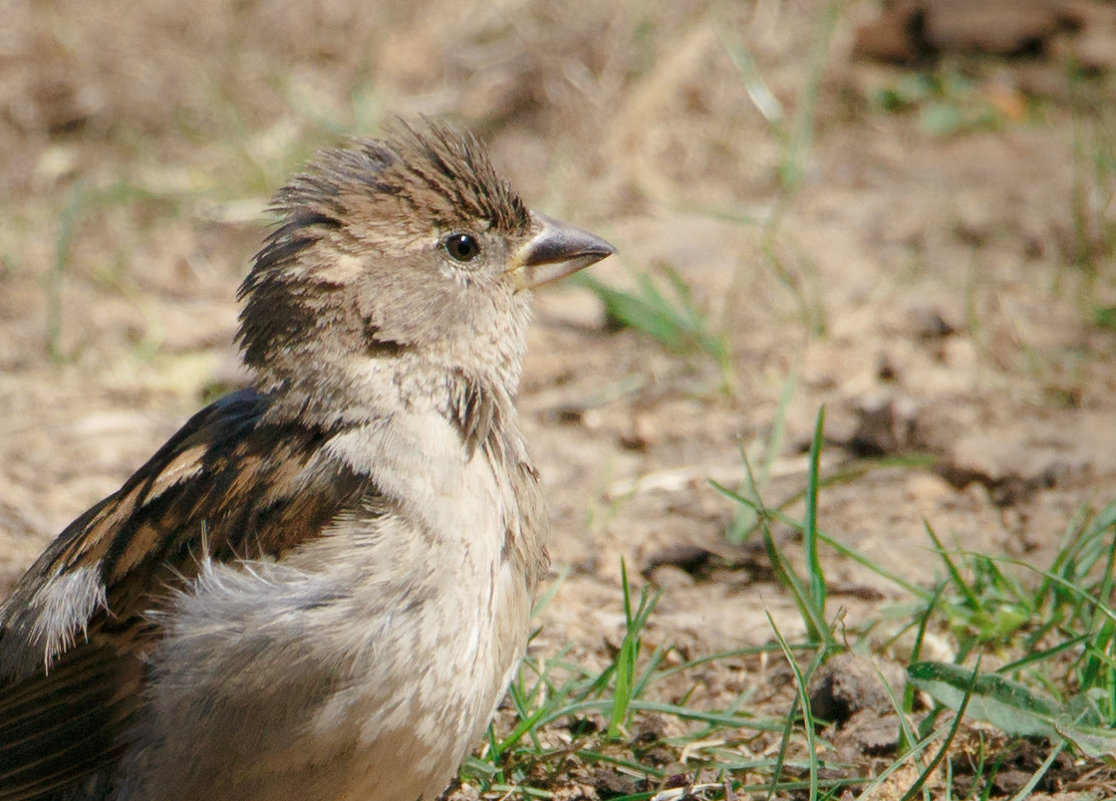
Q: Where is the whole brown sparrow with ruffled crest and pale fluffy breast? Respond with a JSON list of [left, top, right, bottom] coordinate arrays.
[[0, 122, 615, 801]]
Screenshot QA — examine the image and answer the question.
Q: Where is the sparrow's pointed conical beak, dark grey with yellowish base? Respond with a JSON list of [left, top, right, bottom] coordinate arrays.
[[508, 212, 616, 289]]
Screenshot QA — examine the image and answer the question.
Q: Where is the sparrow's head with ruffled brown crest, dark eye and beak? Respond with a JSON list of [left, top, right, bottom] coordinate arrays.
[[238, 124, 615, 419]]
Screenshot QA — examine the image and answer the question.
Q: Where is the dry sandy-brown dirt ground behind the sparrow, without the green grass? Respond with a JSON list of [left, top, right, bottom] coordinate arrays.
[[0, 0, 1116, 798]]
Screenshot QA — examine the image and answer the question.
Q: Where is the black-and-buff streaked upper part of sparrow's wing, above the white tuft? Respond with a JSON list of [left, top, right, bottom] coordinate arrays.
[[48, 390, 367, 590]]
